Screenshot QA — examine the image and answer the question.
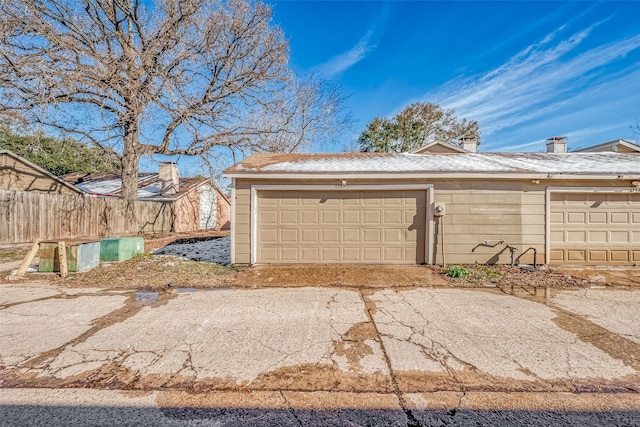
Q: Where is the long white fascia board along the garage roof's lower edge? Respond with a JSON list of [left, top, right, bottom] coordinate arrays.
[[224, 171, 640, 180]]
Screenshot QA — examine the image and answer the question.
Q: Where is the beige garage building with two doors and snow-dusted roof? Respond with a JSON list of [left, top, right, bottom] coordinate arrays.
[[225, 140, 640, 265]]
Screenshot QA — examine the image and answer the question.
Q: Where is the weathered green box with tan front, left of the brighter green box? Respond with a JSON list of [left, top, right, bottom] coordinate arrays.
[[38, 240, 100, 273]]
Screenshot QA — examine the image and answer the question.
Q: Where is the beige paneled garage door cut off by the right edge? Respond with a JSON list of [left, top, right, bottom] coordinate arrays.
[[550, 192, 640, 265]]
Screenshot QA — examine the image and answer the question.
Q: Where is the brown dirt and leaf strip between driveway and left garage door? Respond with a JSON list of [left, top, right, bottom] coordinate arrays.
[[8, 260, 449, 290]]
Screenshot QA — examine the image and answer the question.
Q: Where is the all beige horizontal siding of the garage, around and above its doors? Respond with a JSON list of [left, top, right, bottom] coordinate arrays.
[[232, 179, 628, 264]]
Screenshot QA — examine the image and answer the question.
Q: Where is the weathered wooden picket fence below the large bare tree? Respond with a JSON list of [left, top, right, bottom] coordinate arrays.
[[0, 190, 174, 244]]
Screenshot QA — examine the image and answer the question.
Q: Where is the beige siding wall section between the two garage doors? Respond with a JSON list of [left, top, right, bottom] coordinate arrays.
[[432, 181, 545, 264]]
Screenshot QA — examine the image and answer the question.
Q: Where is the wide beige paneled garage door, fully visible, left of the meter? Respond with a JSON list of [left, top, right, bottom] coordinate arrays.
[[257, 190, 427, 264]]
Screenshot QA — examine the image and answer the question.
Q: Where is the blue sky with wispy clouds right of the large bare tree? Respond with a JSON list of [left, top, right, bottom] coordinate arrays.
[[270, 0, 640, 151]]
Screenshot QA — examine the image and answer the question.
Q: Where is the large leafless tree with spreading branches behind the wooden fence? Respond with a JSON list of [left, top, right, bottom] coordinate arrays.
[[0, 0, 288, 199]]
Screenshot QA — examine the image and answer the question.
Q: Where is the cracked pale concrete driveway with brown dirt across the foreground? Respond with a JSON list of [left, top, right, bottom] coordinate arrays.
[[0, 284, 640, 426]]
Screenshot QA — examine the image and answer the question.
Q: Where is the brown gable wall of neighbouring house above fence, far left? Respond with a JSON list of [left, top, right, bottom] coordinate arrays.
[[0, 153, 79, 195]]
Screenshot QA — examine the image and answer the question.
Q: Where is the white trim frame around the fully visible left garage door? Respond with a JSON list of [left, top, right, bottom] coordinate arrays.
[[248, 184, 434, 265]]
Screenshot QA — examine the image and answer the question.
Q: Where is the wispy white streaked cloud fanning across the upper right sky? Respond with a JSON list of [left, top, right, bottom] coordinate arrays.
[[430, 21, 640, 138]]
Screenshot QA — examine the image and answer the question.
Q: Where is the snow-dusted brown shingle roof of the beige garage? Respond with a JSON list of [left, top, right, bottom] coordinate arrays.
[[225, 152, 640, 177]]
